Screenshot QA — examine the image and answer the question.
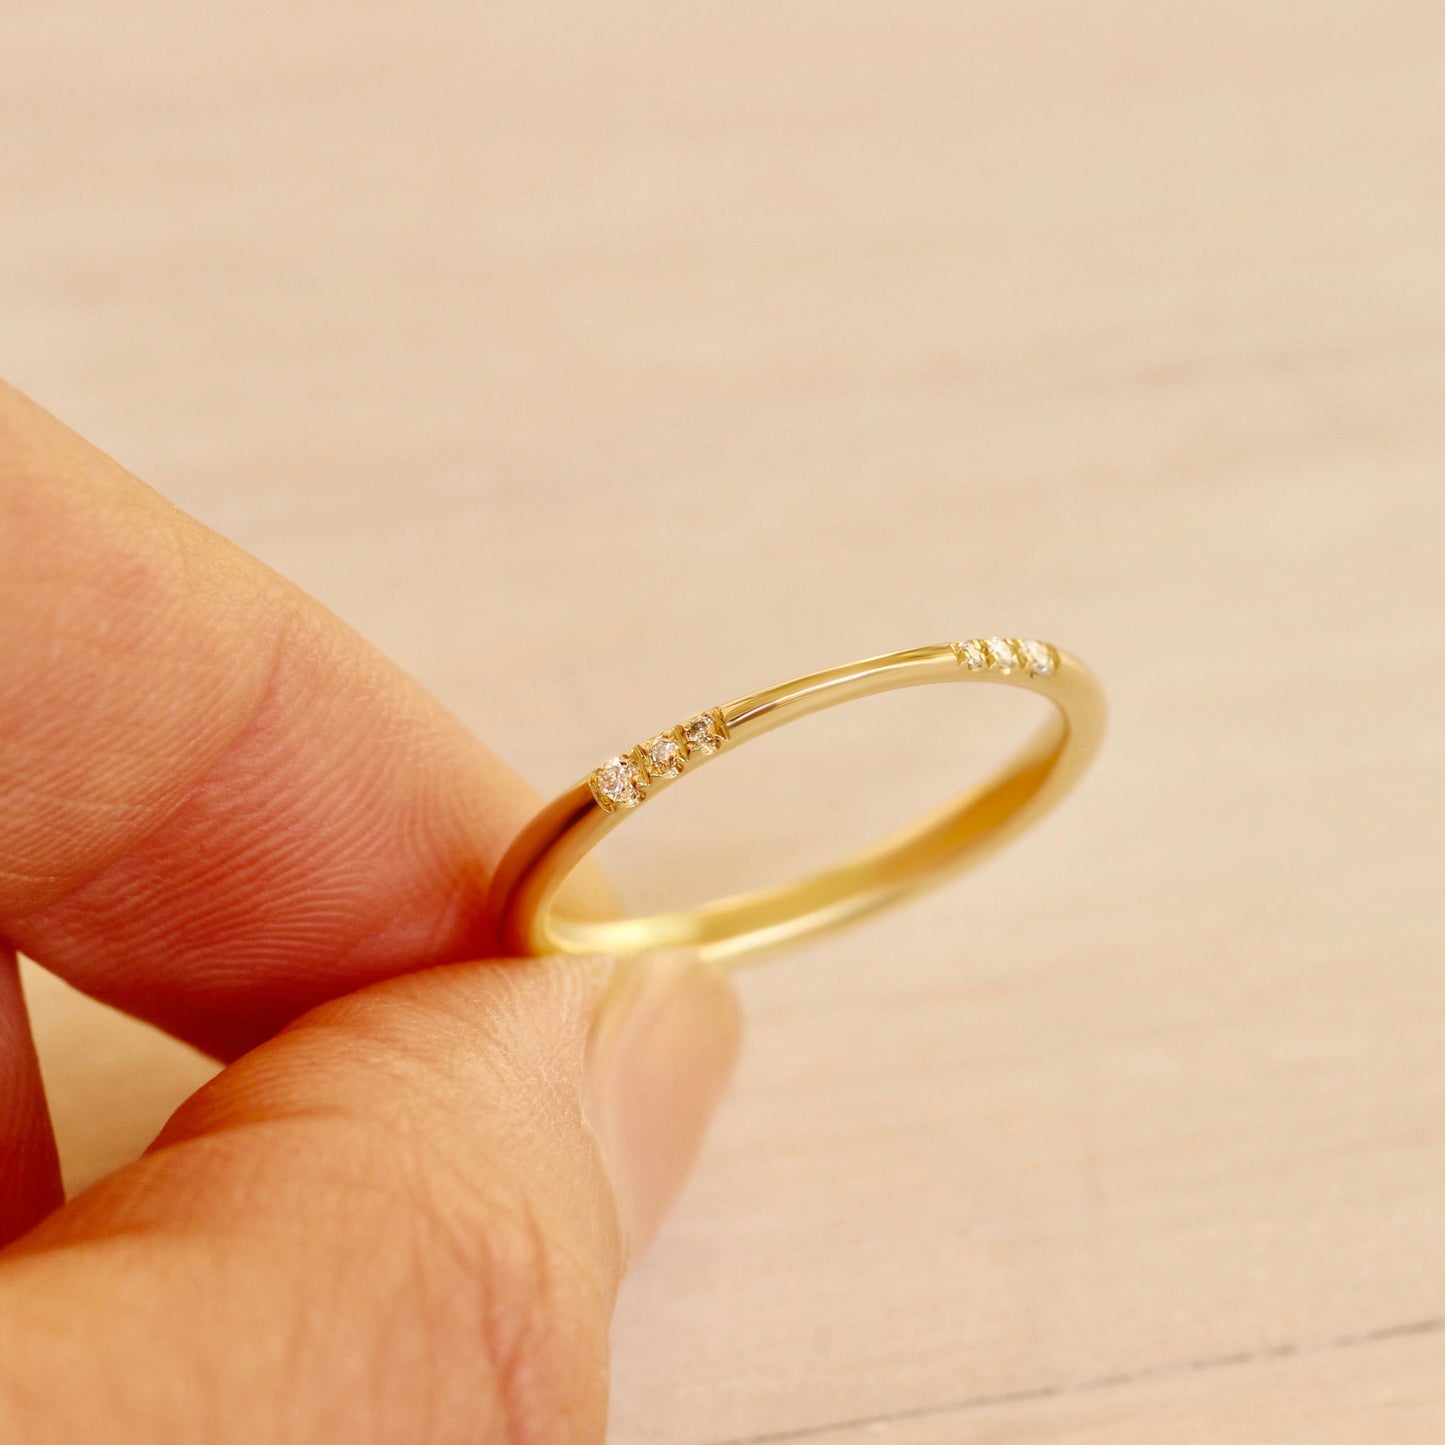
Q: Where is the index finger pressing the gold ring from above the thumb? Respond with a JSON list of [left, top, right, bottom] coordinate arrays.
[[0, 386, 536, 1056]]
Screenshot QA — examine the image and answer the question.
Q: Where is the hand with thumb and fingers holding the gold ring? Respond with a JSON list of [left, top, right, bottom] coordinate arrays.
[[0, 389, 740, 1445]]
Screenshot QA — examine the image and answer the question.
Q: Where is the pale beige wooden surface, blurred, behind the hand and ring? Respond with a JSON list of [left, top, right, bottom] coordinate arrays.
[[0, 0, 1445, 1445]]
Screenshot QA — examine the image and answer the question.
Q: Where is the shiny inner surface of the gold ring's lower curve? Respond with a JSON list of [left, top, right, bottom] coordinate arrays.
[[542, 704, 1069, 959]]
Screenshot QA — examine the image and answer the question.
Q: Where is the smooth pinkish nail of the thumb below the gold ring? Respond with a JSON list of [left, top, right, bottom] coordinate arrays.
[[585, 949, 743, 1257]]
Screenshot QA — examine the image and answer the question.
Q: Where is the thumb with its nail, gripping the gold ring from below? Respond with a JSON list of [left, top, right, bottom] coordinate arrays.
[[0, 957, 740, 1445]]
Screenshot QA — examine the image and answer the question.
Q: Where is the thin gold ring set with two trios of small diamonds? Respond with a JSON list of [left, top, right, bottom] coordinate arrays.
[[490, 637, 1104, 964]]
